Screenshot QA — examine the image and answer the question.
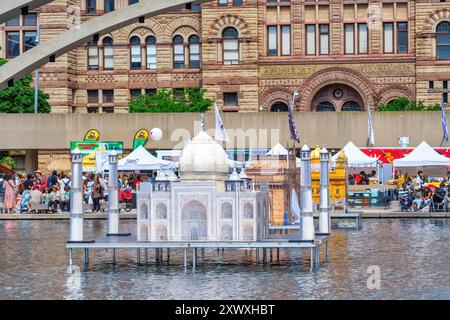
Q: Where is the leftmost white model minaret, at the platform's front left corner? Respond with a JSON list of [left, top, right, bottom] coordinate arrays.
[[69, 148, 83, 241]]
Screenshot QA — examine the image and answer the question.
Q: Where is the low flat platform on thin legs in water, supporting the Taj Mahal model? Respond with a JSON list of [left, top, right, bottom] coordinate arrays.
[[66, 234, 329, 271]]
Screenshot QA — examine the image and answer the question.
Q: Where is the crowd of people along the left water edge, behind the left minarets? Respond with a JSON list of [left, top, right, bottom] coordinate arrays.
[[0, 171, 158, 214]]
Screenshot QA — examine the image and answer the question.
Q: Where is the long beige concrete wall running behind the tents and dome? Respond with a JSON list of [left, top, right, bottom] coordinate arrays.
[[0, 112, 444, 150]]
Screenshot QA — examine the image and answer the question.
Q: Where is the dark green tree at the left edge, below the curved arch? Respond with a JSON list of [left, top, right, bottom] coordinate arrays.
[[0, 59, 50, 113]]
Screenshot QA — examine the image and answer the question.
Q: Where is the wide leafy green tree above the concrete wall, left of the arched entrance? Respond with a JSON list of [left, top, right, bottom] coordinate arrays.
[[128, 88, 213, 113]]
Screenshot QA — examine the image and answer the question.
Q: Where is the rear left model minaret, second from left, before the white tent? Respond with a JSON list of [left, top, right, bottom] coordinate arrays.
[[108, 150, 119, 235]]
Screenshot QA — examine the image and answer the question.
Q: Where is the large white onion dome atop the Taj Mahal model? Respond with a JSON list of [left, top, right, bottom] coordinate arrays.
[[179, 131, 229, 181]]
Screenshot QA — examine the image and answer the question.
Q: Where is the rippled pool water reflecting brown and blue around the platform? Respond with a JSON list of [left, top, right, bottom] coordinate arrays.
[[0, 219, 450, 299]]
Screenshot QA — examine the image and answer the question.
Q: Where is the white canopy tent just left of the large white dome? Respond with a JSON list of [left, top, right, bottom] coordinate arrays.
[[112, 146, 175, 171]]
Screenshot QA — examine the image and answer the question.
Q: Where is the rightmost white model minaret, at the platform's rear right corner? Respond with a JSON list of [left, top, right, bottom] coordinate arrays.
[[319, 148, 331, 234]]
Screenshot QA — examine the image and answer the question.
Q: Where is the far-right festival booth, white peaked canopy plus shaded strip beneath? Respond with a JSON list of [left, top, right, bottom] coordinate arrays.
[[394, 141, 450, 177]]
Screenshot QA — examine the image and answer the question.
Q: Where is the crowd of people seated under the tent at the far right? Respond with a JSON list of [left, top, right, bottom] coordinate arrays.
[[398, 171, 450, 212]]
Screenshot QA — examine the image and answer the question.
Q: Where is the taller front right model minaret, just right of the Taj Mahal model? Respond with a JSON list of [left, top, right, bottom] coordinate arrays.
[[300, 144, 315, 241]]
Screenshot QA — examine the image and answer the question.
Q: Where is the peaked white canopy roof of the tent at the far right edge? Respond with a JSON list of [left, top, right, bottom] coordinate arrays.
[[394, 141, 450, 168]]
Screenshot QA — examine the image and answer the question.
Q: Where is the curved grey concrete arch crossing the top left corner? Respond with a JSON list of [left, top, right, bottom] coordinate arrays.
[[0, 0, 209, 89]]
